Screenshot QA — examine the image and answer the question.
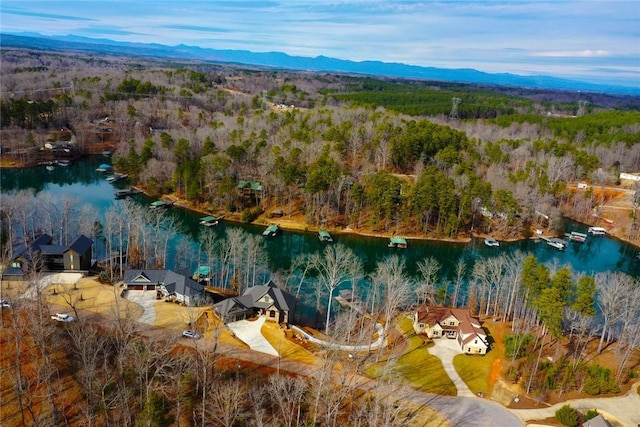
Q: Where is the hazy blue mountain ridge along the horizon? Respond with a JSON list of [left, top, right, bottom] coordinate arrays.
[[0, 33, 640, 95]]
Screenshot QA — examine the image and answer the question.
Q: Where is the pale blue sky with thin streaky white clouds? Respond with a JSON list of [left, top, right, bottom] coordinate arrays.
[[0, 0, 640, 87]]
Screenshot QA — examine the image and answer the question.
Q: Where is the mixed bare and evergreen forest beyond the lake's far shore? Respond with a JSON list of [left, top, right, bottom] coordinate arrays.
[[0, 46, 640, 242]]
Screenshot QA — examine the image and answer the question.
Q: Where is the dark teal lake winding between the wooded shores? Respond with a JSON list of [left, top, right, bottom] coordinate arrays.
[[0, 156, 640, 280]]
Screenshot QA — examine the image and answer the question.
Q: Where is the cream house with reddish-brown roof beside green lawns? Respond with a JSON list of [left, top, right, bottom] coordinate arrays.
[[413, 305, 489, 354]]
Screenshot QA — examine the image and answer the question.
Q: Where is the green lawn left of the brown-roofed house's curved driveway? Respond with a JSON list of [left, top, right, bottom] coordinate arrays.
[[367, 316, 457, 396]]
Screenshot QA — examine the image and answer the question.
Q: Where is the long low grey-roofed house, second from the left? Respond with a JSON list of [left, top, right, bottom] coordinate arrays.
[[123, 270, 204, 306]]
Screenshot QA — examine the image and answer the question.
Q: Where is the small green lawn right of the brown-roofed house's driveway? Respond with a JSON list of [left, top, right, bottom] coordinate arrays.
[[453, 324, 502, 394]]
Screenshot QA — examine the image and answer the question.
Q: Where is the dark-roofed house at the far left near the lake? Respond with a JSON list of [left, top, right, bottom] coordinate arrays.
[[2, 234, 93, 280]]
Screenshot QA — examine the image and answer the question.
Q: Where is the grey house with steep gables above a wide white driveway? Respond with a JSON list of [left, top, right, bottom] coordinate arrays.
[[214, 280, 296, 323]]
